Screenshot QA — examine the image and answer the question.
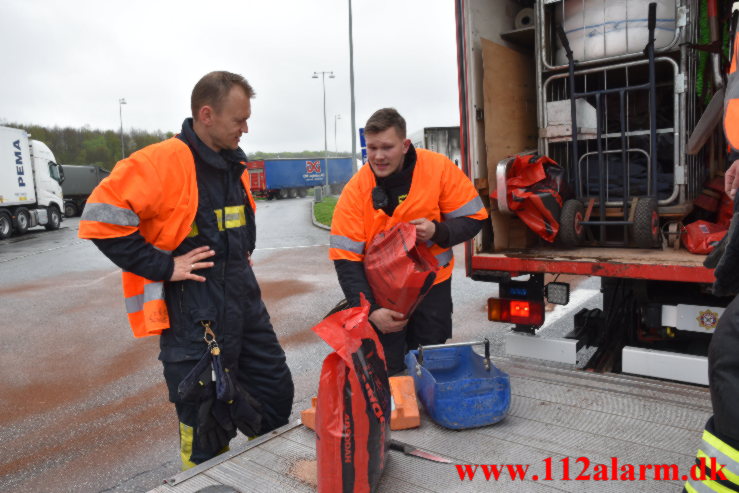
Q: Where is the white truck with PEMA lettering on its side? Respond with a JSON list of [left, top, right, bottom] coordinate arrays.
[[0, 127, 64, 240]]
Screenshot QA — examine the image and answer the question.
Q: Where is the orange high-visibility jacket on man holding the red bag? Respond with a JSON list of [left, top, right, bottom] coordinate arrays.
[[329, 149, 488, 284]]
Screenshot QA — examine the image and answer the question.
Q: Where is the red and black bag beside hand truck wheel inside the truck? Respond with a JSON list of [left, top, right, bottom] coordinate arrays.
[[490, 154, 564, 243]]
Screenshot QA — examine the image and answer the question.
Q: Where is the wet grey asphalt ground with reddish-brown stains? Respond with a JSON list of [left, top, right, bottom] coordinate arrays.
[[0, 198, 576, 492]]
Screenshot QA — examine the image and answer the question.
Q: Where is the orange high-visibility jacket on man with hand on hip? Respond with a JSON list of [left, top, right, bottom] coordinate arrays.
[[78, 137, 255, 337]]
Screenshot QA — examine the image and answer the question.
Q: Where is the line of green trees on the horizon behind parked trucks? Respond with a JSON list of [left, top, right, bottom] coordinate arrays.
[[2, 123, 358, 170]]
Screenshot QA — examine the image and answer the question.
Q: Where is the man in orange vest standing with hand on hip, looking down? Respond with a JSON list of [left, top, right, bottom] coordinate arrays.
[[79, 72, 293, 469]]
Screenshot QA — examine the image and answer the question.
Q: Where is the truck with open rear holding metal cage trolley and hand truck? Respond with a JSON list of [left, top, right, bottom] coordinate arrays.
[[457, 0, 730, 385]]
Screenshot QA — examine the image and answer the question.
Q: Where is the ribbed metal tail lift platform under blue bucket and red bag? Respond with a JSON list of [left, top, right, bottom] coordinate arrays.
[[152, 358, 711, 493]]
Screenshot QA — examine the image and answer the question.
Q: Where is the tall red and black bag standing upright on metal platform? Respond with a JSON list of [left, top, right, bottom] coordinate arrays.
[[313, 295, 390, 493]]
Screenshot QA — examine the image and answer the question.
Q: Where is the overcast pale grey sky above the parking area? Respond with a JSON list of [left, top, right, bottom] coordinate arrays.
[[0, 0, 459, 153]]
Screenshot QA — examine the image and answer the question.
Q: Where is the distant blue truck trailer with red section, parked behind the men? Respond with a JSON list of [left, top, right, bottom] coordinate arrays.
[[246, 158, 352, 200]]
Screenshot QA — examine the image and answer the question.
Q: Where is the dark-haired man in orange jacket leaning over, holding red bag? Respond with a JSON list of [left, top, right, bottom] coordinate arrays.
[[329, 108, 487, 375]]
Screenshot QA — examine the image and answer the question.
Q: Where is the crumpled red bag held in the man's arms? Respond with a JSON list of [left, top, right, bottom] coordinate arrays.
[[364, 223, 440, 318]]
